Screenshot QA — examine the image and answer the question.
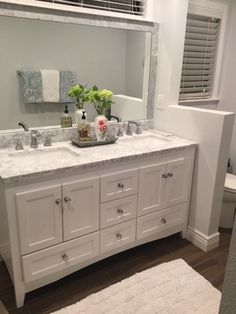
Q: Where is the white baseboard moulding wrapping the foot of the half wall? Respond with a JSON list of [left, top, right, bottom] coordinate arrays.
[[185, 227, 220, 252]]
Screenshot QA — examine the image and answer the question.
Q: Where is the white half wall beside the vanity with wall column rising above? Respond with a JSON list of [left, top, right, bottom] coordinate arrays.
[[155, 0, 234, 250]]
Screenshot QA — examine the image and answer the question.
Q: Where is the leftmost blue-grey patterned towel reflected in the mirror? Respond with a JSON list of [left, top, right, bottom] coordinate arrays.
[[17, 71, 43, 103]]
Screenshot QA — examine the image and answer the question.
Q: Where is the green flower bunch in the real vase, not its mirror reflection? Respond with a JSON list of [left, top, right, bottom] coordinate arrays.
[[88, 86, 113, 115]]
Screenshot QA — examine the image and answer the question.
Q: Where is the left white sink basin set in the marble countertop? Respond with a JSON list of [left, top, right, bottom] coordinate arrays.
[[8, 147, 79, 163]]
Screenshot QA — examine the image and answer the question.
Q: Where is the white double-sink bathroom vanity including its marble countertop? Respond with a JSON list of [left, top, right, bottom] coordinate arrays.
[[0, 131, 196, 307]]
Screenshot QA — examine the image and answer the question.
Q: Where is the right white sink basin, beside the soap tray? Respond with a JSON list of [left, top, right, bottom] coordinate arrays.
[[119, 134, 173, 146]]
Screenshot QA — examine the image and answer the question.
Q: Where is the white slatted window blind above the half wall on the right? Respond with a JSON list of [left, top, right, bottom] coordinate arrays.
[[180, 14, 220, 100]]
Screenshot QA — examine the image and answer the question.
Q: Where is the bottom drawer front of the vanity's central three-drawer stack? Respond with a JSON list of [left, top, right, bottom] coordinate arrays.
[[100, 220, 136, 253]]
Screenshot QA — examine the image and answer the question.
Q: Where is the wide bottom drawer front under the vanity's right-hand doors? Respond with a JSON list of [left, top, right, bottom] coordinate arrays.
[[137, 203, 187, 240]]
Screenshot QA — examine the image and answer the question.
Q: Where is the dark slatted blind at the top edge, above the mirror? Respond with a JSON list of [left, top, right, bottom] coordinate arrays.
[[35, 0, 146, 16]]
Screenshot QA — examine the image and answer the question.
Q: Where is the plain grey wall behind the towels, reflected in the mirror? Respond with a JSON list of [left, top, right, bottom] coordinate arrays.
[[0, 17, 127, 129]]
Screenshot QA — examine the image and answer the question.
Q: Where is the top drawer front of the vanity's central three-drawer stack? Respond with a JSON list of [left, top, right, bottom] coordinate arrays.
[[101, 169, 138, 203]]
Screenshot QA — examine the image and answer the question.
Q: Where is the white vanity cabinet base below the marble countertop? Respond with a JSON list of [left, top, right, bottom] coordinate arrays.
[[1, 146, 195, 307]]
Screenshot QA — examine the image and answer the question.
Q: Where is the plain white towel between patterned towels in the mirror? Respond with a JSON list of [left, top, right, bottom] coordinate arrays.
[[41, 70, 59, 102]]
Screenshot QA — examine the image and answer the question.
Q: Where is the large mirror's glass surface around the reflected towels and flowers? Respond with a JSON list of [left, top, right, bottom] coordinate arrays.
[[0, 16, 151, 130]]
